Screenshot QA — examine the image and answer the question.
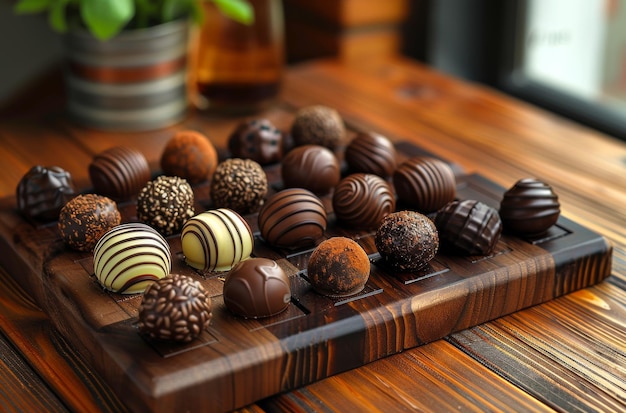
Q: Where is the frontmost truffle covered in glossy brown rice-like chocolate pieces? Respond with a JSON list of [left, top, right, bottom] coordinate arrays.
[[137, 273, 212, 343]]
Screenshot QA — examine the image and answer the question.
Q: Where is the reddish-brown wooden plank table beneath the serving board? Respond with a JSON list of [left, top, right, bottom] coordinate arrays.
[[0, 60, 626, 412]]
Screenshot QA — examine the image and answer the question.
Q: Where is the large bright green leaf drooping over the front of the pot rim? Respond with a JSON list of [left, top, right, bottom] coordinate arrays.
[[80, 0, 135, 40]]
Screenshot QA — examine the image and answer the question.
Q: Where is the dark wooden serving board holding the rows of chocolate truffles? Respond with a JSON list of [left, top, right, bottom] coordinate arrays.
[[0, 142, 611, 412]]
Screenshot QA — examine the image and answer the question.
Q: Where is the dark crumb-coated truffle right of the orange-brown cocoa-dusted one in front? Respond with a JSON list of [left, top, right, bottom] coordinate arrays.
[[374, 211, 439, 271]]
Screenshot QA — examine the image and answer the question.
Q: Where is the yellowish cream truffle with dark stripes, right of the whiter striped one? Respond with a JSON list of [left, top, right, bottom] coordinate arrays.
[[181, 208, 254, 271]]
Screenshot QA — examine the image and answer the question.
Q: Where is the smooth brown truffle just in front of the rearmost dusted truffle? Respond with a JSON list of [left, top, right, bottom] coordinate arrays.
[[281, 145, 341, 194]]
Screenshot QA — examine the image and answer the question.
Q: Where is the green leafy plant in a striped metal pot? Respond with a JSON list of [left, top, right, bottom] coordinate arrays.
[[14, 0, 253, 131]]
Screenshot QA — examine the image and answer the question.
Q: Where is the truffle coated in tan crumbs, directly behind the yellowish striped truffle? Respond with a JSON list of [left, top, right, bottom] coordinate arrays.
[[211, 158, 268, 215]]
